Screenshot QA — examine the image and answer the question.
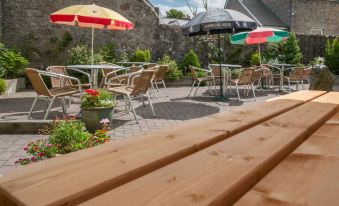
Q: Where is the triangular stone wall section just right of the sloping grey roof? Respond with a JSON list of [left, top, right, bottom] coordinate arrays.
[[262, 0, 291, 25]]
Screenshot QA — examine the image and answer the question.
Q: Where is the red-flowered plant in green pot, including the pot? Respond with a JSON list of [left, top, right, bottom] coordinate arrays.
[[81, 89, 116, 132]]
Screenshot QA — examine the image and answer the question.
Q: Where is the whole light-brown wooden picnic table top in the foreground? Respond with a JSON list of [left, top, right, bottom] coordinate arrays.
[[0, 91, 339, 206]]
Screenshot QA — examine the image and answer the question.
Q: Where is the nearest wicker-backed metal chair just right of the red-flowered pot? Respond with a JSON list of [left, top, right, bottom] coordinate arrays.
[[107, 70, 156, 123]]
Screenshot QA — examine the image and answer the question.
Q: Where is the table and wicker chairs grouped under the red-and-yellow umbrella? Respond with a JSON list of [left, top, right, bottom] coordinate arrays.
[[26, 62, 168, 122]]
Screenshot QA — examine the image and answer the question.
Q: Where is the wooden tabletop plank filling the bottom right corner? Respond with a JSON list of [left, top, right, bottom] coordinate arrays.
[[235, 110, 339, 206]]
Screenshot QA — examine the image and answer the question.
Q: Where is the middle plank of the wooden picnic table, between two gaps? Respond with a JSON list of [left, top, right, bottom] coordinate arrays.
[[82, 93, 339, 206]]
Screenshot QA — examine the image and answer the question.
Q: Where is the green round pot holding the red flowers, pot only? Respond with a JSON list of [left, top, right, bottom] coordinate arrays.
[[82, 107, 114, 133]]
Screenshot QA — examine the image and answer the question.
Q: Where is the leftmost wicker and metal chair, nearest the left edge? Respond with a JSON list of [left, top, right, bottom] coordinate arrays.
[[25, 68, 82, 120]]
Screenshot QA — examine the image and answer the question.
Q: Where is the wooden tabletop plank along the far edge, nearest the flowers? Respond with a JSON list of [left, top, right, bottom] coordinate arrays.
[[0, 91, 325, 206]]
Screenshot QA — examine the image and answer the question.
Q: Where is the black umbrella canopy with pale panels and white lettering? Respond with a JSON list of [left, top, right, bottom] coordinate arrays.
[[183, 9, 257, 36]]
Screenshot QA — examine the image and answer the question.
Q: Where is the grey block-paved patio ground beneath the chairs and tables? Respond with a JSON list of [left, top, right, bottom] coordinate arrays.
[[0, 87, 308, 175]]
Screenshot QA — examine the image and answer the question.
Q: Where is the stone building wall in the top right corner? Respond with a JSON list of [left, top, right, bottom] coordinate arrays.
[[292, 0, 339, 36]]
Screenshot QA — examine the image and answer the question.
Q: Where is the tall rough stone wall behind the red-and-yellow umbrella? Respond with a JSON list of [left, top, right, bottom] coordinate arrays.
[[0, 0, 182, 67]]
